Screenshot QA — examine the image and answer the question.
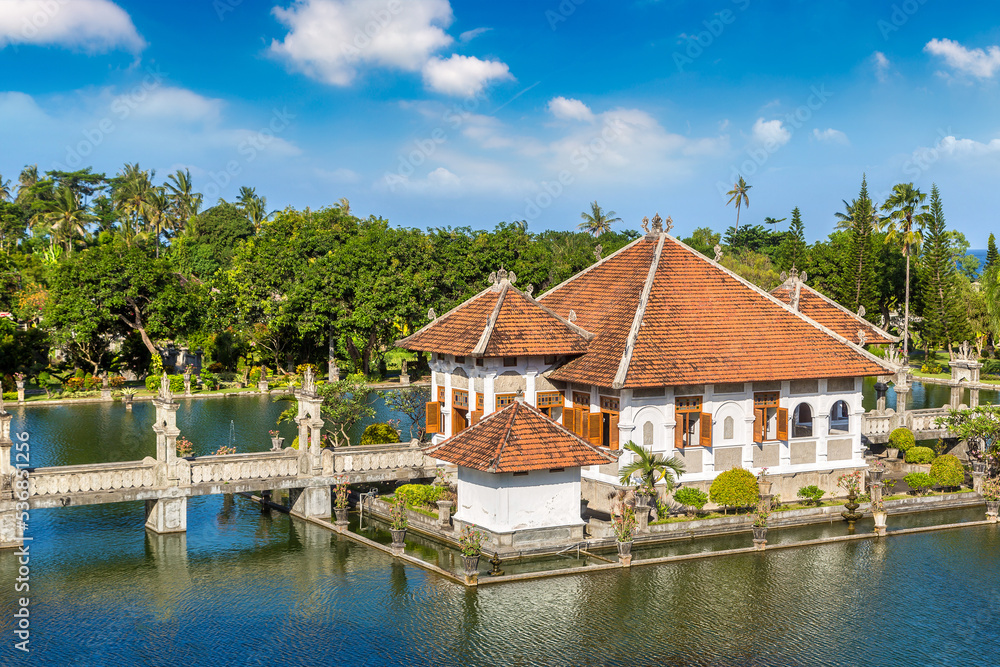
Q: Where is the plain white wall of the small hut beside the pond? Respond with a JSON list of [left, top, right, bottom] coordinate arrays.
[[455, 466, 583, 533]]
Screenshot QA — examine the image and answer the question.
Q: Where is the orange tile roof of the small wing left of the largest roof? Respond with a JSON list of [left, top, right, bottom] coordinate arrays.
[[396, 280, 593, 357]]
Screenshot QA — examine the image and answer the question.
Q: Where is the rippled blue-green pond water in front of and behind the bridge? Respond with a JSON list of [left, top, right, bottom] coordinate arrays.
[[0, 388, 1000, 667]]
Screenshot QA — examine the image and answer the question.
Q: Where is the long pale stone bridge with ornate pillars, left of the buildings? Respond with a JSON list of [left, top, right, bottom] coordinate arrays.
[[0, 373, 435, 548]]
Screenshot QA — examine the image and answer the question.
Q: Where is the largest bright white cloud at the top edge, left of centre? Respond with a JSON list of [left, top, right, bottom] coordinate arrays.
[[271, 0, 453, 86]]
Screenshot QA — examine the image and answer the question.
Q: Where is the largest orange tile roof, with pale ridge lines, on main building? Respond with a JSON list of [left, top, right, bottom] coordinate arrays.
[[539, 233, 893, 388]]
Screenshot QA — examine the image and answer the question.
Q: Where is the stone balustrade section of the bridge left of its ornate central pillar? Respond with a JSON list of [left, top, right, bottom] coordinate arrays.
[[28, 456, 157, 496]]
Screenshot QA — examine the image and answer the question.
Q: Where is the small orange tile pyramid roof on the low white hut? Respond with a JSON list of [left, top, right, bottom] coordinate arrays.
[[424, 402, 616, 473]]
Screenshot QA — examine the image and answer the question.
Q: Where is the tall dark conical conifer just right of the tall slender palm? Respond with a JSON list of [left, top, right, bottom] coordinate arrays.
[[918, 185, 969, 350]]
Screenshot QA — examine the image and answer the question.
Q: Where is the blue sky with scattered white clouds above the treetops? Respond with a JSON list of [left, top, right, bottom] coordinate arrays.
[[0, 0, 1000, 247]]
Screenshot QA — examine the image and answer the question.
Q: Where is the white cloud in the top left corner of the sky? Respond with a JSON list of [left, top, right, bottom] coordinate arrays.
[[0, 0, 146, 52]]
